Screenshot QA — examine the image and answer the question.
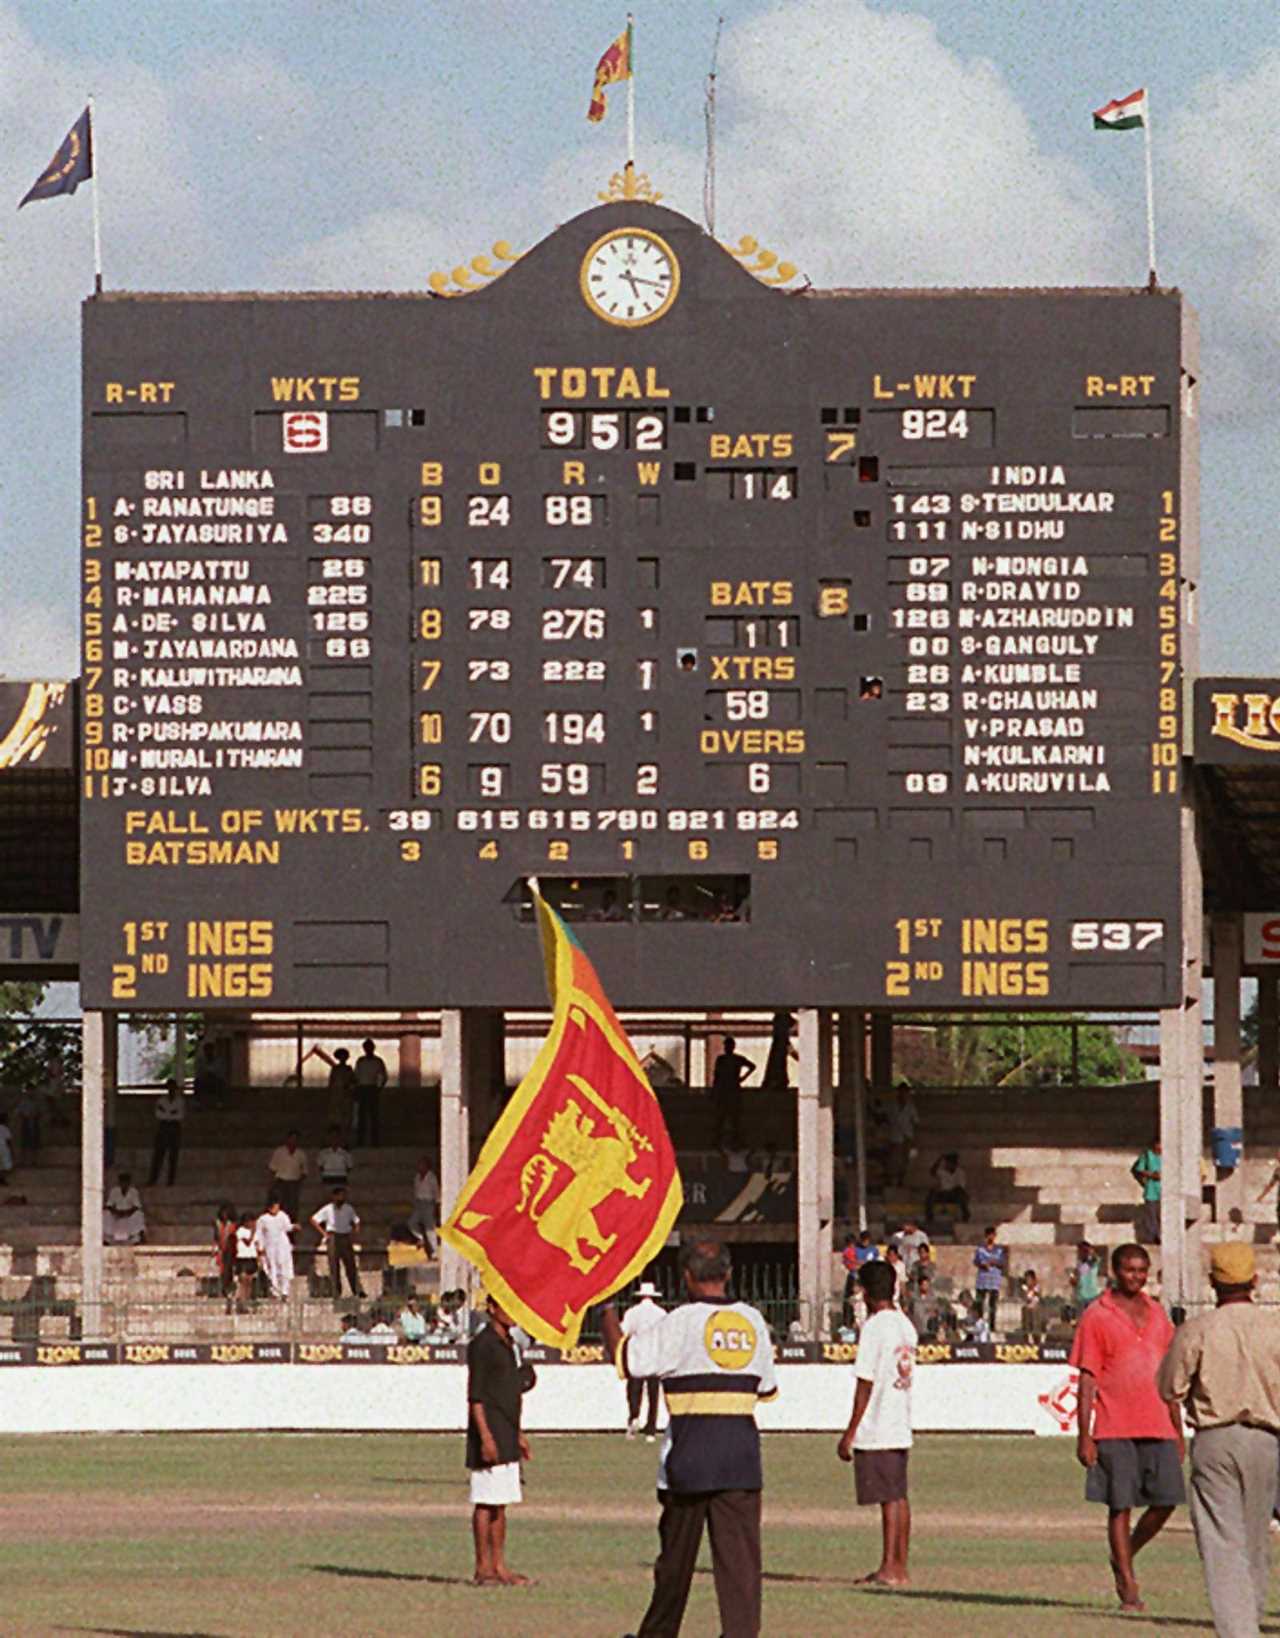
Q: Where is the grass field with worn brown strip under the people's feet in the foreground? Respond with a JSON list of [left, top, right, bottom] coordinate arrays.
[[0, 1435, 1258, 1638]]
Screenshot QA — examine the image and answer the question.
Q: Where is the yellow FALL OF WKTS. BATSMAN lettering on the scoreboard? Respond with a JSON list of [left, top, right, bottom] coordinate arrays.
[[125, 808, 369, 867]]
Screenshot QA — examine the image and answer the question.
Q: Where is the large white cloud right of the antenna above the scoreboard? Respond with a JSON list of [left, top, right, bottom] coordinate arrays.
[[718, 0, 1124, 285]]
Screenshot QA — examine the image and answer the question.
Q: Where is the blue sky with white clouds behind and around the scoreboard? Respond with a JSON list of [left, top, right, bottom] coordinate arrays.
[[0, 0, 1280, 676]]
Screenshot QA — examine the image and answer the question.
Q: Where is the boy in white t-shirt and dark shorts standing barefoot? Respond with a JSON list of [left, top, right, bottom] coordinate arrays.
[[836, 1263, 916, 1587]]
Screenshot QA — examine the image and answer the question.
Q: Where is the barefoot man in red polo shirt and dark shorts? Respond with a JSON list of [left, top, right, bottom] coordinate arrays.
[[1070, 1245, 1187, 1610]]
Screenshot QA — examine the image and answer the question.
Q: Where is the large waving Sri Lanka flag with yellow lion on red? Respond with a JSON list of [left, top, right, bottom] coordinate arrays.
[[441, 886, 683, 1348]]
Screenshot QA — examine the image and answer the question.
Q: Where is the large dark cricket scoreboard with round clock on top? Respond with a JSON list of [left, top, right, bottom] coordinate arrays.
[[82, 205, 1191, 1007]]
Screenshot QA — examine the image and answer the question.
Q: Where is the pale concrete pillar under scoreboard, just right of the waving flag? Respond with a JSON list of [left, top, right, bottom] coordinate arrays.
[[797, 1007, 834, 1338]]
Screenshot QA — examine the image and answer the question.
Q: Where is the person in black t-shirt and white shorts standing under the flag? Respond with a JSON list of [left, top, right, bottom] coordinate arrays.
[[467, 1297, 536, 1587]]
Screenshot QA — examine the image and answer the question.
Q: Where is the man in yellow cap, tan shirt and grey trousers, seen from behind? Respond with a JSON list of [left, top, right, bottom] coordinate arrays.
[[1157, 1240, 1280, 1638]]
